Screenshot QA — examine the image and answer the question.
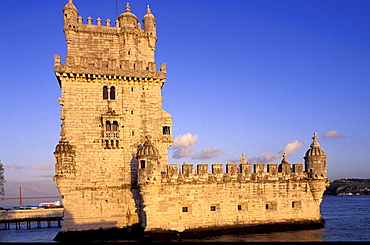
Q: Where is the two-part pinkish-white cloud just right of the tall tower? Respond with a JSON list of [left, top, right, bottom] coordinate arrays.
[[171, 133, 222, 160]]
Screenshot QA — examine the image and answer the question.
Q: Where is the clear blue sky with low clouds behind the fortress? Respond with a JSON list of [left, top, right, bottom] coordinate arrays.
[[0, 0, 370, 206]]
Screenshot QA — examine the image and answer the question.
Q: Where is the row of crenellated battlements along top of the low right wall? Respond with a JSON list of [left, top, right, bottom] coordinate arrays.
[[155, 163, 308, 184]]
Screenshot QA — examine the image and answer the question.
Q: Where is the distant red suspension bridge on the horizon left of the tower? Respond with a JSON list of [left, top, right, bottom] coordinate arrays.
[[3, 186, 62, 206]]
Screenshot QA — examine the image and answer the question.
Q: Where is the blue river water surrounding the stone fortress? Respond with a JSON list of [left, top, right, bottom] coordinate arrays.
[[0, 195, 370, 243]]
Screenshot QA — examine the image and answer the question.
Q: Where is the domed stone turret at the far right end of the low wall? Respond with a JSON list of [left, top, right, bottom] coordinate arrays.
[[303, 132, 327, 179]]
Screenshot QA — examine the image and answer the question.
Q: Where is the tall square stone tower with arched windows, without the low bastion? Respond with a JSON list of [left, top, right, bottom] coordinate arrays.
[[54, 0, 172, 232]]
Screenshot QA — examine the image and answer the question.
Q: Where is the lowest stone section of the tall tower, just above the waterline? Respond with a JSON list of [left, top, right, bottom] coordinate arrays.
[[61, 186, 139, 232]]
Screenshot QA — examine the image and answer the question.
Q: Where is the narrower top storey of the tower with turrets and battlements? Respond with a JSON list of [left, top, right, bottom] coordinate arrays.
[[58, 1, 162, 80]]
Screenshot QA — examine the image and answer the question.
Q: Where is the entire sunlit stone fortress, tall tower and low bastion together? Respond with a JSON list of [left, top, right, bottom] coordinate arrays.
[[54, 0, 328, 240]]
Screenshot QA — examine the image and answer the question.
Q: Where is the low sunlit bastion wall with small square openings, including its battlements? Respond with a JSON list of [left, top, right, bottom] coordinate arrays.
[[140, 164, 325, 232]]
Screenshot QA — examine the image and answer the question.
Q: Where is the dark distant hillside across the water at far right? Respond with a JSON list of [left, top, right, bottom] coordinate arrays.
[[324, 179, 370, 196]]
